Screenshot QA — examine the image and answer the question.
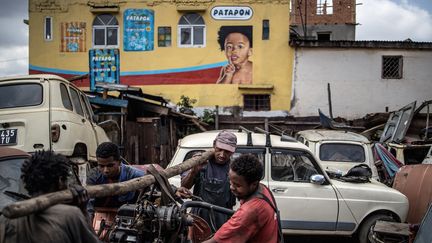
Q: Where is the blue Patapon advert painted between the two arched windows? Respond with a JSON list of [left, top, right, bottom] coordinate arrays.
[[123, 9, 154, 51]]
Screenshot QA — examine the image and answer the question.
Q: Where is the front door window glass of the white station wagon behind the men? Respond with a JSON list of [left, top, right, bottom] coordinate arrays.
[[271, 149, 318, 182]]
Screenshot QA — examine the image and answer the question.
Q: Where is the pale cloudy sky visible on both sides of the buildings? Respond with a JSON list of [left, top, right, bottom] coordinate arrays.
[[0, 0, 432, 77]]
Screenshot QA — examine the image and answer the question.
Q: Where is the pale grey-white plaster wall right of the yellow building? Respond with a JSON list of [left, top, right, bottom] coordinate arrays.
[[290, 48, 432, 119]]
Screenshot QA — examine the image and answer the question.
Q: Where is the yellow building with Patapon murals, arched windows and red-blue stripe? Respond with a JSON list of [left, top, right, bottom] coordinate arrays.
[[29, 0, 293, 110]]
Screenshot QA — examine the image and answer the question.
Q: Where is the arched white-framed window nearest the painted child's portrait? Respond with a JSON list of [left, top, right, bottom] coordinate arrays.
[[177, 13, 206, 47]]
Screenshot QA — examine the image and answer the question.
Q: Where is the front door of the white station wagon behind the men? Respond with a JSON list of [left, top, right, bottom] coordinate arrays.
[[268, 148, 338, 231]]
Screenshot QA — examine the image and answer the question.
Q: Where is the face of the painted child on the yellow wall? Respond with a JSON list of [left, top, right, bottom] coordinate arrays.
[[225, 33, 252, 65]]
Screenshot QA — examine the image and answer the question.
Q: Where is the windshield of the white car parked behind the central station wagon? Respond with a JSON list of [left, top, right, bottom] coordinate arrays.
[[319, 143, 365, 163]]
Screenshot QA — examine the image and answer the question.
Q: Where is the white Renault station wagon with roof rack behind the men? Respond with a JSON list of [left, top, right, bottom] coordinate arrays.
[[169, 131, 408, 243]]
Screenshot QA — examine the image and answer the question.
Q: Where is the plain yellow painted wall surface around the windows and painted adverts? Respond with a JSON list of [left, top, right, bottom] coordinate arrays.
[[29, 0, 293, 110]]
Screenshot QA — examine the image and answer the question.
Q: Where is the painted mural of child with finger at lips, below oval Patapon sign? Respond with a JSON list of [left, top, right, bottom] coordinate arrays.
[[216, 26, 253, 84]]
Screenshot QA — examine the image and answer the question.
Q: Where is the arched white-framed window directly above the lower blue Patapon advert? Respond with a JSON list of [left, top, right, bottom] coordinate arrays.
[[93, 14, 119, 48]]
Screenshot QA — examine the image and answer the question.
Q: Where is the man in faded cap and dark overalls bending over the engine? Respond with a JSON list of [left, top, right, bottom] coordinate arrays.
[[181, 131, 237, 230]]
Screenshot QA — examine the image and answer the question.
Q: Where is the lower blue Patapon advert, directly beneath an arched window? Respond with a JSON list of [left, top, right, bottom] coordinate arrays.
[[89, 49, 120, 91]]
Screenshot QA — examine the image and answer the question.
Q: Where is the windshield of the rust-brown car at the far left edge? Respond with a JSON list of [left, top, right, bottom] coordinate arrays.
[[0, 158, 27, 209]]
